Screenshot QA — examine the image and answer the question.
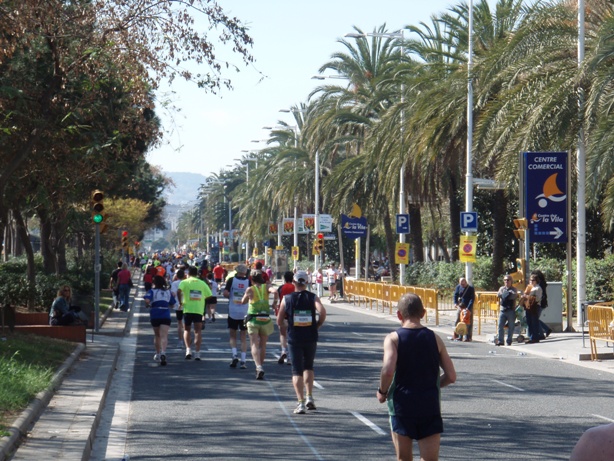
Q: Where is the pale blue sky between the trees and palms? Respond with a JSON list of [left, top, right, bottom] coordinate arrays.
[[147, 0, 458, 176]]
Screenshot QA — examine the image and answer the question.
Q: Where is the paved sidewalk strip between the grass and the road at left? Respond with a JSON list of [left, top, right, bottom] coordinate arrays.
[[0, 294, 131, 461]]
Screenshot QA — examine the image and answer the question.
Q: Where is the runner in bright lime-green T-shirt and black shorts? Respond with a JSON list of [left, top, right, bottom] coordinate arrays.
[[177, 266, 211, 360]]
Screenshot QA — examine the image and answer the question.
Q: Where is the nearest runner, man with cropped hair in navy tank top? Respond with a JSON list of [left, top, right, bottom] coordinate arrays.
[[377, 294, 456, 461]]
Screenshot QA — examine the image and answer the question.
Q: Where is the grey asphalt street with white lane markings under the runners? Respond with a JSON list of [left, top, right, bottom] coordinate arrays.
[[91, 292, 614, 461]]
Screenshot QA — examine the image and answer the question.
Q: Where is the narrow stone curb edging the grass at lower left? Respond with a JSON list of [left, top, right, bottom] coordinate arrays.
[[0, 343, 85, 461]]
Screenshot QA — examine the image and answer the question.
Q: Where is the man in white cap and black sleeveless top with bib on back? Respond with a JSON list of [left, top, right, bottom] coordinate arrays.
[[277, 271, 326, 414]]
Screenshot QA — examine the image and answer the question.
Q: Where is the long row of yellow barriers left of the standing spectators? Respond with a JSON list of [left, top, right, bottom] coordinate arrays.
[[343, 279, 439, 325]]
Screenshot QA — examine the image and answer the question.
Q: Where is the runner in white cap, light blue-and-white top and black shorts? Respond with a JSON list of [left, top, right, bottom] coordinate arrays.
[[224, 264, 251, 369]]
